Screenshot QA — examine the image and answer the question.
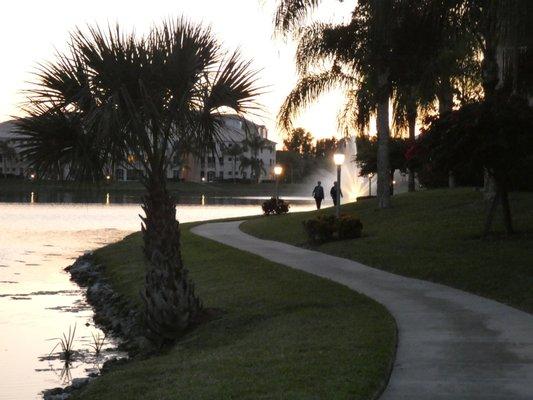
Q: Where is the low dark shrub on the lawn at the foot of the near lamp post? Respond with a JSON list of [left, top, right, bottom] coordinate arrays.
[[302, 215, 363, 244]]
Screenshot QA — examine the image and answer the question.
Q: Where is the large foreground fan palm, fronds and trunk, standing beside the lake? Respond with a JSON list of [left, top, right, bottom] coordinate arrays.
[[20, 19, 259, 344]]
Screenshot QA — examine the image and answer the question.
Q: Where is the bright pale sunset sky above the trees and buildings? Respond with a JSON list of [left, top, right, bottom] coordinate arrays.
[[0, 0, 354, 147]]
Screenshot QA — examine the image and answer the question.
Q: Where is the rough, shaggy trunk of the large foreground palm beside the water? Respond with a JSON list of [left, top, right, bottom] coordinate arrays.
[[142, 171, 201, 345]]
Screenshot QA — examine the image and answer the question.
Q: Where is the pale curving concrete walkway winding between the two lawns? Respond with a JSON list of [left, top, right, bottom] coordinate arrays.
[[192, 221, 533, 400]]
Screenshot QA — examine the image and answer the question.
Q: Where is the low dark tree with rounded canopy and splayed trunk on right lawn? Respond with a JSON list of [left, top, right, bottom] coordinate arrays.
[[417, 93, 533, 236]]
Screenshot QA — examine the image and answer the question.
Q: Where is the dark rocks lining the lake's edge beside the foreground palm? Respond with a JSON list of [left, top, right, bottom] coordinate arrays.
[[42, 252, 147, 400]]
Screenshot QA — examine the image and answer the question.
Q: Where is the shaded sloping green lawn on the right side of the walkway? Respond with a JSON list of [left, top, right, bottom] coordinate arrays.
[[241, 189, 533, 313]]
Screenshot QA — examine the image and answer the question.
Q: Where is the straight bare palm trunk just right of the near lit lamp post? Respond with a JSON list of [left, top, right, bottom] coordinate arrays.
[[377, 76, 391, 208]]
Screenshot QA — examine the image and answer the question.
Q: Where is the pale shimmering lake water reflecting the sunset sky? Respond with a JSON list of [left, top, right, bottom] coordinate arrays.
[[0, 193, 312, 400]]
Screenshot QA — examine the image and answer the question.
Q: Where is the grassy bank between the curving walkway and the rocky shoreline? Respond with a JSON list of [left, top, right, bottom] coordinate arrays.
[[76, 225, 395, 399]]
